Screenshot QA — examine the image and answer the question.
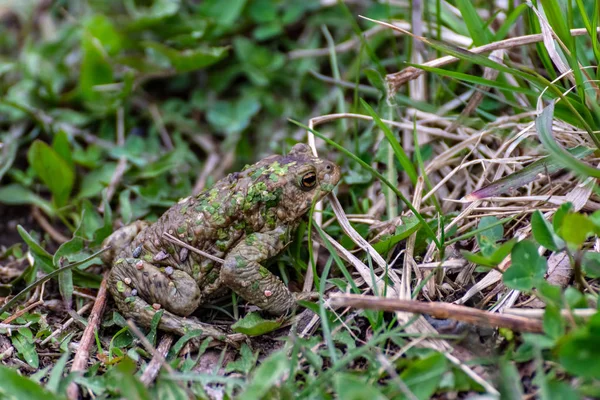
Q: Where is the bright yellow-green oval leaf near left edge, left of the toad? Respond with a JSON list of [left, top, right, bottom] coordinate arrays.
[[27, 140, 75, 207]]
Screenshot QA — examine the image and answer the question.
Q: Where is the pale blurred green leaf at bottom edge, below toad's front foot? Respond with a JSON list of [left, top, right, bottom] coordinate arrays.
[[238, 350, 290, 400]]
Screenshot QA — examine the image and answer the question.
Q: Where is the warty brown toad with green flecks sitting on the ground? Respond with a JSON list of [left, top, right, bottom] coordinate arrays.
[[102, 144, 340, 339]]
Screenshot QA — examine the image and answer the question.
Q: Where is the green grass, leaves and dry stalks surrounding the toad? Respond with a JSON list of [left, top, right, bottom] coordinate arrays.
[[0, 0, 600, 399]]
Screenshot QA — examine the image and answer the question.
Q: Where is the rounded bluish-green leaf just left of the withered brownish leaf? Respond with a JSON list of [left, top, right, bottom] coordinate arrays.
[[502, 240, 547, 291]]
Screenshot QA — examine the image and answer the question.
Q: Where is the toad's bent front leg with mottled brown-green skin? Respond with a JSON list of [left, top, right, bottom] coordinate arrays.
[[221, 227, 296, 315]]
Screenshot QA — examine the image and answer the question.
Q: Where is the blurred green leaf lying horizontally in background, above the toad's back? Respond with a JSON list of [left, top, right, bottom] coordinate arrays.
[[143, 41, 229, 72]]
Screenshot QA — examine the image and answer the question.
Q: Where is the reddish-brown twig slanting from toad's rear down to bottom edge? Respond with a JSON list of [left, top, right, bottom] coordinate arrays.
[[67, 276, 107, 400]]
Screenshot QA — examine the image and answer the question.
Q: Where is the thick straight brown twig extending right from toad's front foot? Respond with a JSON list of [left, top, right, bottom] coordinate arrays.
[[329, 294, 543, 333]]
